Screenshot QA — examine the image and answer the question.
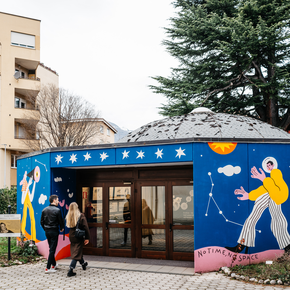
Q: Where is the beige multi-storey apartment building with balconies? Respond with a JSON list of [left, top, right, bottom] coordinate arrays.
[[0, 12, 58, 188]]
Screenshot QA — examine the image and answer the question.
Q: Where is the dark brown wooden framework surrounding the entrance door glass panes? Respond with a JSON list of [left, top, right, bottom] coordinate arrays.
[[77, 165, 194, 261]]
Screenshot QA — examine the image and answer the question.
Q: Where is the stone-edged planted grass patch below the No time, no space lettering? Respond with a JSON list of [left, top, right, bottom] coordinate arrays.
[[230, 253, 290, 284]]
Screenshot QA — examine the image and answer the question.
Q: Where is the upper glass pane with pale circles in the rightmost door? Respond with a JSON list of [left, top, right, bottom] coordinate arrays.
[[173, 185, 193, 225]]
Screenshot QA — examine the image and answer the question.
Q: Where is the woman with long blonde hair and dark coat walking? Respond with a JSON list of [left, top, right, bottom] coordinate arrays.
[[66, 202, 90, 277]]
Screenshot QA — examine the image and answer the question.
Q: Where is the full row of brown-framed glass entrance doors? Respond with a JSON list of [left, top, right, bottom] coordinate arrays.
[[81, 181, 194, 261]]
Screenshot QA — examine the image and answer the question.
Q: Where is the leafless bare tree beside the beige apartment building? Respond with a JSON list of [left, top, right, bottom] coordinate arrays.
[[24, 85, 99, 150]]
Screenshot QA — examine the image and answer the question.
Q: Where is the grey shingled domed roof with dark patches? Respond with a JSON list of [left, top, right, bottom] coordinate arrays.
[[118, 108, 290, 143]]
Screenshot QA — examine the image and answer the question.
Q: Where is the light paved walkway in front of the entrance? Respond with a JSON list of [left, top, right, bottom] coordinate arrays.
[[0, 259, 290, 290]]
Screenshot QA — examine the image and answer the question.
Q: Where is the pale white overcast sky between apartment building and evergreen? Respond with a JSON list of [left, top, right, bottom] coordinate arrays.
[[0, 0, 177, 130]]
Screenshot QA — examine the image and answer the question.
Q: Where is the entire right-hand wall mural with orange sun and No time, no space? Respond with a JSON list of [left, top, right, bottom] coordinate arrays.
[[194, 143, 290, 272]]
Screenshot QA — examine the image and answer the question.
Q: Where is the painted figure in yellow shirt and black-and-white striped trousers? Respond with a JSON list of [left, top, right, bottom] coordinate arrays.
[[227, 157, 290, 253]]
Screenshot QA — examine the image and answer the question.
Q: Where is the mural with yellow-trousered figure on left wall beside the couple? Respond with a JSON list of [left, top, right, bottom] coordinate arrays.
[[17, 153, 75, 260]]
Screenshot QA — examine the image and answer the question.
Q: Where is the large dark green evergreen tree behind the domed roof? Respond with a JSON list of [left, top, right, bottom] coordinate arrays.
[[150, 0, 290, 130]]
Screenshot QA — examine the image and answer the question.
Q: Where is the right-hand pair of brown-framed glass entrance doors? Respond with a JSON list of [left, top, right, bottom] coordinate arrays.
[[136, 181, 194, 261]]
